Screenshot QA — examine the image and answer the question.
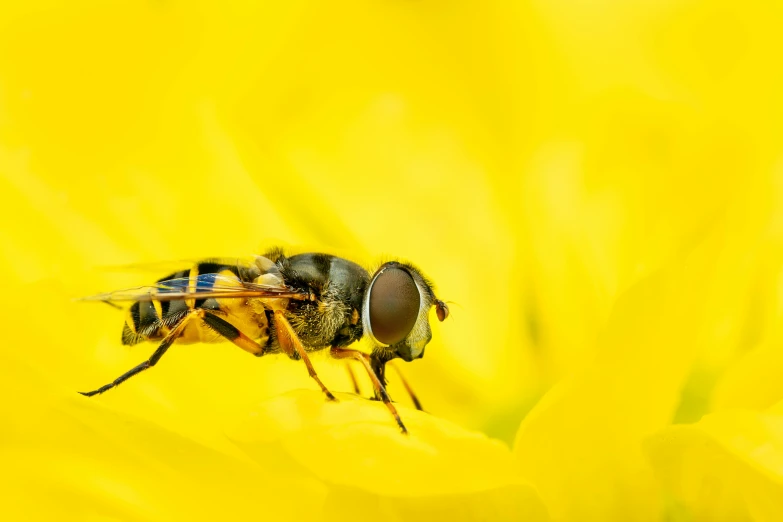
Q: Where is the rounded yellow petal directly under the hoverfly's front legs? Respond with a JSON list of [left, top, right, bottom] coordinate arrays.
[[228, 391, 548, 520]]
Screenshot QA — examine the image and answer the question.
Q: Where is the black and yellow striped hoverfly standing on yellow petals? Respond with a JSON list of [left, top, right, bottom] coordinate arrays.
[[80, 249, 449, 433]]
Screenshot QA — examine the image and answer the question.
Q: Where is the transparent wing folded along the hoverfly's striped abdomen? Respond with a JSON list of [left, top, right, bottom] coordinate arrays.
[[80, 274, 312, 303]]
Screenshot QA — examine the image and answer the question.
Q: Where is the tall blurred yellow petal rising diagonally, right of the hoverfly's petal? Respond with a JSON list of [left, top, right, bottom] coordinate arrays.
[[514, 225, 740, 520]]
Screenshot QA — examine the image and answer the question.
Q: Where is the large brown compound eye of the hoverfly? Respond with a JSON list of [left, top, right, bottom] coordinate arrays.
[[370, 268, 421, 344]]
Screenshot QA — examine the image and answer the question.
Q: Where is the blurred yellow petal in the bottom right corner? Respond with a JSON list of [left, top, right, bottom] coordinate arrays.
[[648, 411, 783, 522]]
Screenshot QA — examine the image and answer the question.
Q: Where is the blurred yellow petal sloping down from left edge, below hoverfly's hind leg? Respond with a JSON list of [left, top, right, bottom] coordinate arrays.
[[0, 359, 327, 521]]
